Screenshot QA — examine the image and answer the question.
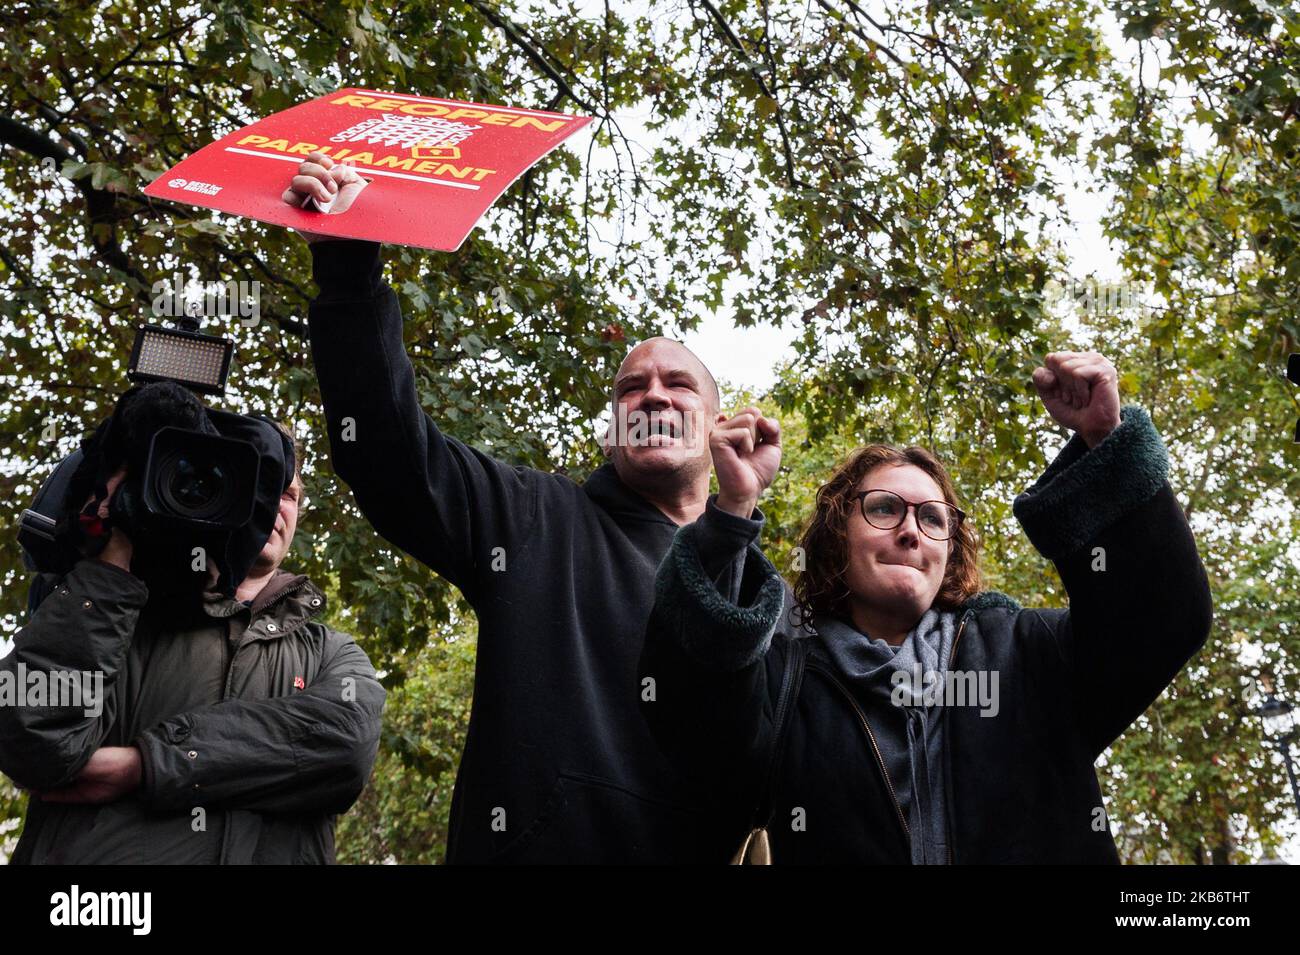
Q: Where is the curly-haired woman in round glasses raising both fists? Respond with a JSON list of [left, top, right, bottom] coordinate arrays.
[[641, 352, 1212, 864]]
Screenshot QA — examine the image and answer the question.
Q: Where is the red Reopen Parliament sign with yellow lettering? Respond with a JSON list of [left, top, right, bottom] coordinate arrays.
[[144, 88, 592, 251]]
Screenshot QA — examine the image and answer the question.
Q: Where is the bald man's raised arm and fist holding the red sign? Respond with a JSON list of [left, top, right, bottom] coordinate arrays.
[[285, 157, 540, 599]]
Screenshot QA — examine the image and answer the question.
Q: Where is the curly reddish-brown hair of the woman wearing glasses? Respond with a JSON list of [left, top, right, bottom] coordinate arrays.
[[794, 444, 982, 626]]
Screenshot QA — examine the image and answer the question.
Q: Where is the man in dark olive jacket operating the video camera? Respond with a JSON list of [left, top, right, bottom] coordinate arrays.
[[0, 420, 385, 864]]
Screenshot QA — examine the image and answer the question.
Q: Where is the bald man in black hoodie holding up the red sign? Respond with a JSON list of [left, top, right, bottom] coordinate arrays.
[[283, 155, 754, 863]]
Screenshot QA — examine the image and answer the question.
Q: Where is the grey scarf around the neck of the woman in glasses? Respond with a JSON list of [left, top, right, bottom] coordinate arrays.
[[814, 607, 959, 865]]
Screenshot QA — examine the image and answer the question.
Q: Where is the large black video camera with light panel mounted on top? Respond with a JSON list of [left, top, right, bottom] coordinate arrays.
[[18, 317, 295, 609]]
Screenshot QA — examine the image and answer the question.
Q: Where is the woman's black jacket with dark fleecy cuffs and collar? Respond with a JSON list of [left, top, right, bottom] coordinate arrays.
[[642, 407, 1212, 864]]
